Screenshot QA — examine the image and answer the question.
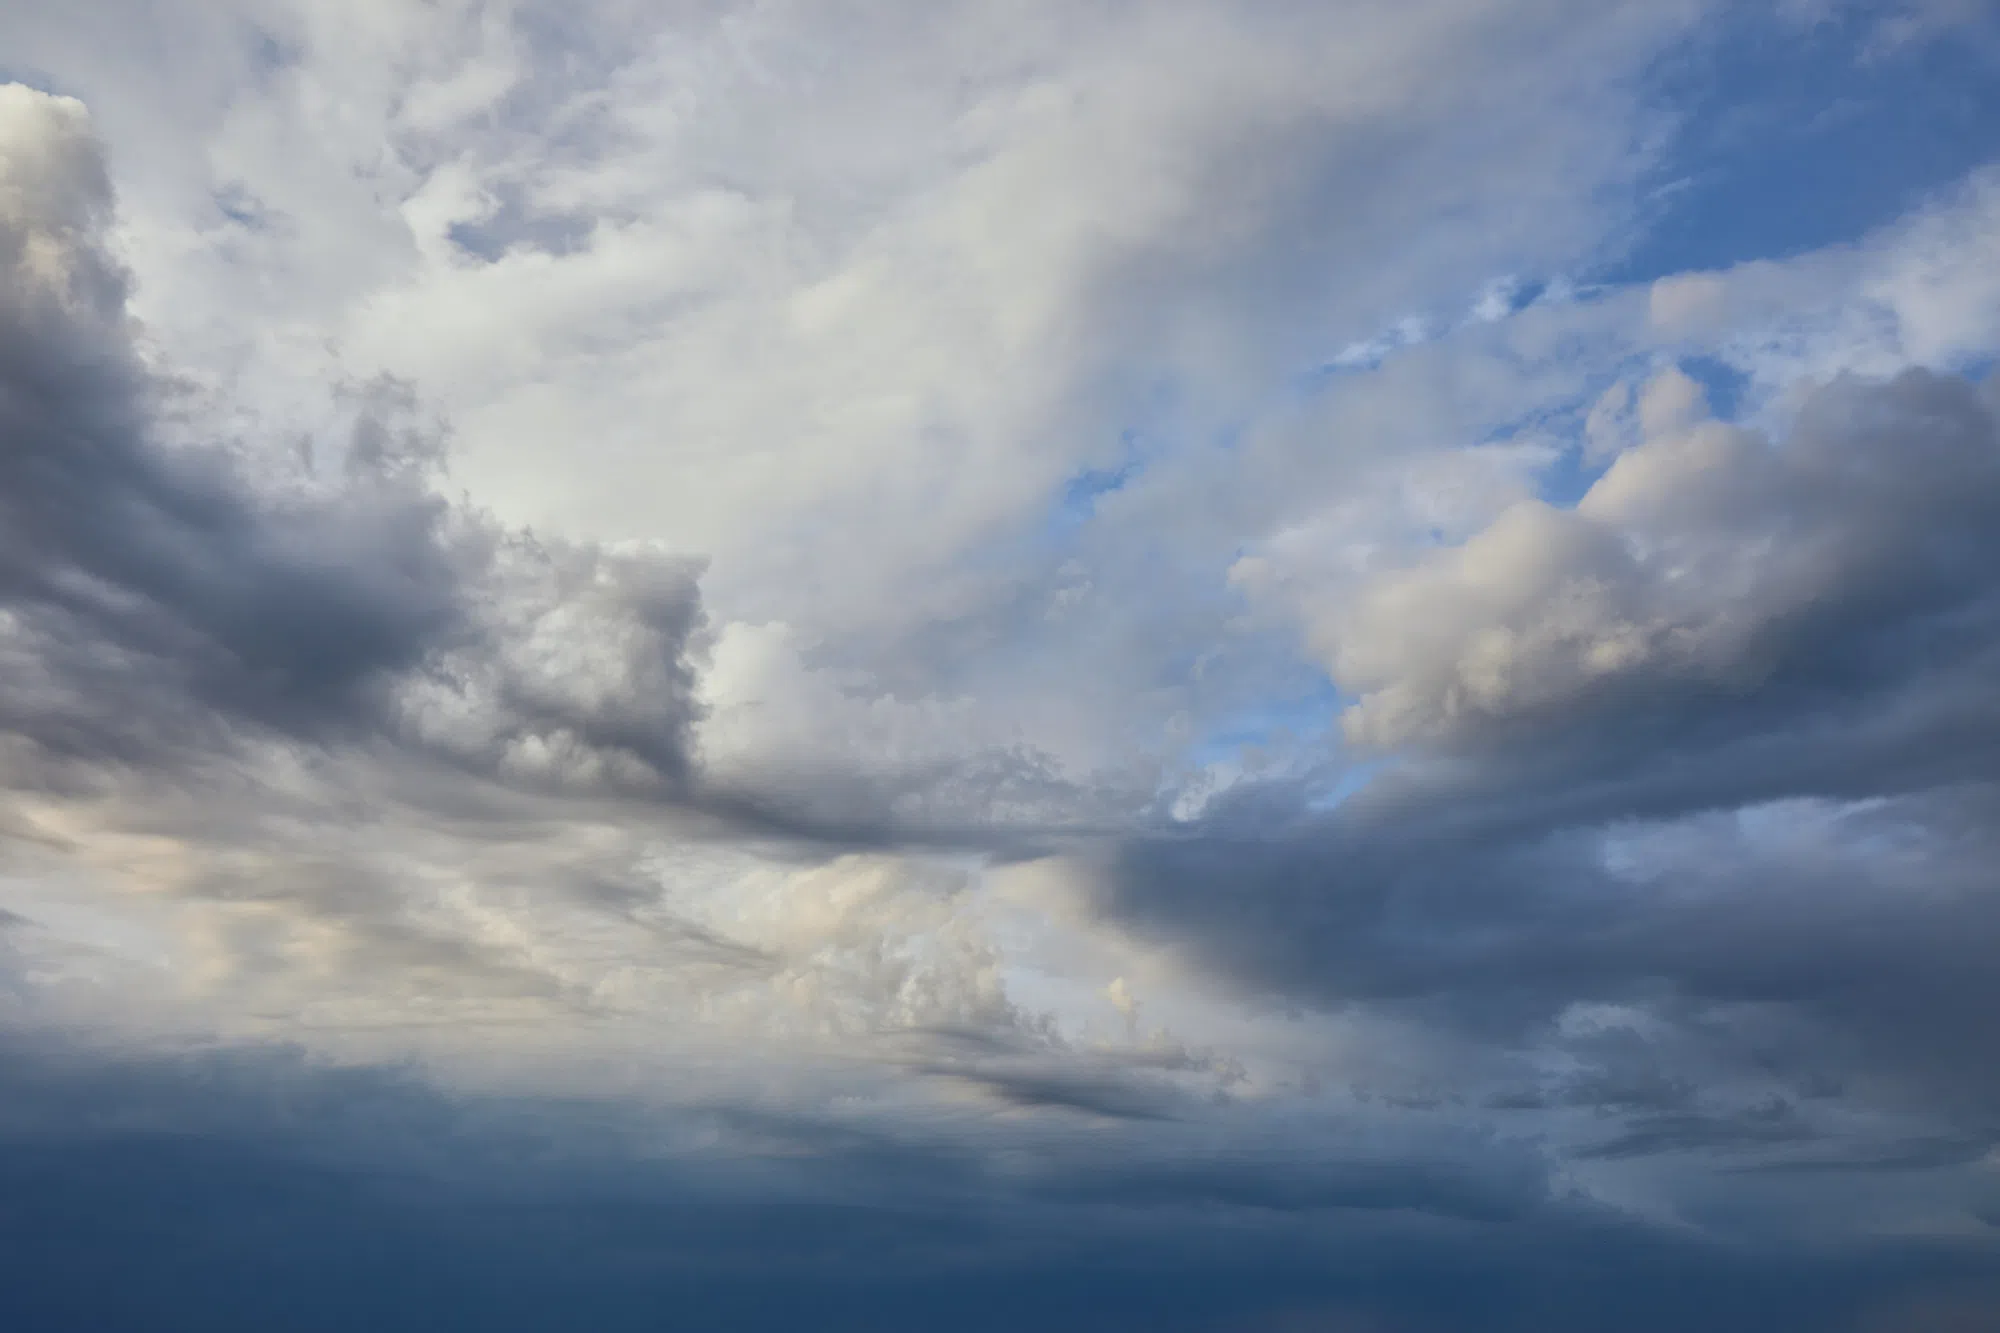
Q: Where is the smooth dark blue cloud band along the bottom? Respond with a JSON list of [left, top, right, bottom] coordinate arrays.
[[0, 1041, 2000, 1333]]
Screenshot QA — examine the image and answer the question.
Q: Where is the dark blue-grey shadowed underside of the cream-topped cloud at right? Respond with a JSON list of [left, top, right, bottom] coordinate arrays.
[[1106, 372, 2000, 1157]]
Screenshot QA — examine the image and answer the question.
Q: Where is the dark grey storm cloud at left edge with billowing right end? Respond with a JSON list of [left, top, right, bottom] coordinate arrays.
[[0, 86, 702, 791]]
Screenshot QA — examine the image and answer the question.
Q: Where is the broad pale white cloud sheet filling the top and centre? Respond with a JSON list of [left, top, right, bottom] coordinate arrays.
[[10, 0, 1728, 839]]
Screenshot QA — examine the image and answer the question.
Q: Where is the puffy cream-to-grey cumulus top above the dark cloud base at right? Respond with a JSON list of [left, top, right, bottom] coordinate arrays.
[[1312, 370, 2000, 745]]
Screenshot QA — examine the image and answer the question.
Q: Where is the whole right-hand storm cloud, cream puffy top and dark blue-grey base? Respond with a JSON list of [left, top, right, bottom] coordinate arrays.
[[1106, 370, 2000, 1155]]
